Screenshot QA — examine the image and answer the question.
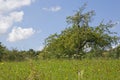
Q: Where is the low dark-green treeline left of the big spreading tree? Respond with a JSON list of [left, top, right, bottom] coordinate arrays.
[[0, 42, 40, 61]]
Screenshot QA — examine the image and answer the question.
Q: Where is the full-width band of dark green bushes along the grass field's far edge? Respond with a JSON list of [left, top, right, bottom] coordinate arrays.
[[0, 42, 120, 62]]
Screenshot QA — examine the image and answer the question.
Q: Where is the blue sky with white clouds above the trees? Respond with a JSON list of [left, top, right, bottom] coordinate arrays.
[[0, 0, 120, 50]]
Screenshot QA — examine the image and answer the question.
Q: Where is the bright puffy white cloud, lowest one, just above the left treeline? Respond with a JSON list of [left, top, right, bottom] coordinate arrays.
[[7, 27, 35, 42]]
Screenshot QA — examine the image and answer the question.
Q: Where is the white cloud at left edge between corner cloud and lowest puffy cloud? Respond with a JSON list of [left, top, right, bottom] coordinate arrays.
[[0, 11, 24, 34]]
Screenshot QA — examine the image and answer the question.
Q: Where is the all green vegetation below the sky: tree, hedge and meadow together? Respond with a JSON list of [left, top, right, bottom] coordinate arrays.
[[0, 5, 120, 80]]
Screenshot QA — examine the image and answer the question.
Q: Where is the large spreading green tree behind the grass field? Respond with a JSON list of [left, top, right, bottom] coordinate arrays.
[[43, 5, 118, 59]]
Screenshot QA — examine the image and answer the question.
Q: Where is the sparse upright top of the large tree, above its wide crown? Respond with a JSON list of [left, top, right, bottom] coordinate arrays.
[[67, 4, 95, 27]]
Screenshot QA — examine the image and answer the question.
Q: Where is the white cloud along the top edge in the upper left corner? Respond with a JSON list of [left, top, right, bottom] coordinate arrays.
[[0, 0, 33, 13]]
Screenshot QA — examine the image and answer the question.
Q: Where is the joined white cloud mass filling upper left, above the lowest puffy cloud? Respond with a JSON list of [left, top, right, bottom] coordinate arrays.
[[0, 0, 35, 35]]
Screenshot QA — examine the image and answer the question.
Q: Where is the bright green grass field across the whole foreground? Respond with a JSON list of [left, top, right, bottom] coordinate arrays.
[[0, 60, 120, 80]]
